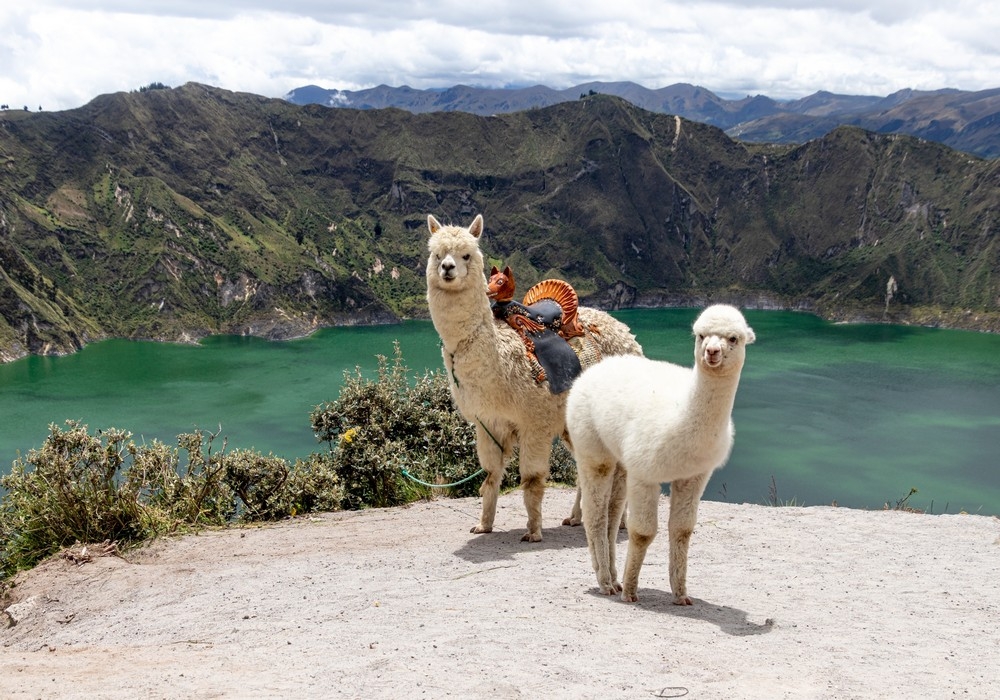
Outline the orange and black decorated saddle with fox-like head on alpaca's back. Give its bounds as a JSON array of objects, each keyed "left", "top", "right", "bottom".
[{"left": 486, "top": 266, "right": 599, "bottom": 394}]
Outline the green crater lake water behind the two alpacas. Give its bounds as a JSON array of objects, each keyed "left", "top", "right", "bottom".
[{"left": 0, "top": 309, "right": 1000, "bottom": 514}]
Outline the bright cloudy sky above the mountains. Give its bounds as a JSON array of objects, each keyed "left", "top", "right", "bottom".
[{"left": 0, "top": 0, "right": 1000, "bottom": 111}]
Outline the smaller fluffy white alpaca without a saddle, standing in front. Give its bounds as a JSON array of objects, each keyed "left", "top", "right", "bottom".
[{"left": 566, "top": 305, "right": 756, "bottom": 605}]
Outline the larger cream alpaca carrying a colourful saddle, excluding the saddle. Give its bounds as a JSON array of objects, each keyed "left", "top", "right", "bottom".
[{"left": 427, "top": 215, "right": 642, "bottom": 542}]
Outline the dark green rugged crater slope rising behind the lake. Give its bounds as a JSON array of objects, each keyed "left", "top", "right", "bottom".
[{"left": 0, "top": 84, "right": 1000, "bottom": 358}]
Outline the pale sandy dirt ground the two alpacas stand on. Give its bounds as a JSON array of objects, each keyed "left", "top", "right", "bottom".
[{"left": 0, "top": 489, "right": 1000, "bottom": 700}]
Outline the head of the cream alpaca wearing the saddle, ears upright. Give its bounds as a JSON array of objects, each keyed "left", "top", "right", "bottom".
[{"left": 427, "top": 214, "right": 486, "bottom": 291}]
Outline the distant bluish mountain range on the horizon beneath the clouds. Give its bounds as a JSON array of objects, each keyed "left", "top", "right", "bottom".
[{"left": 285, "top": 82, "right": 1000, "bottom": 158}]
